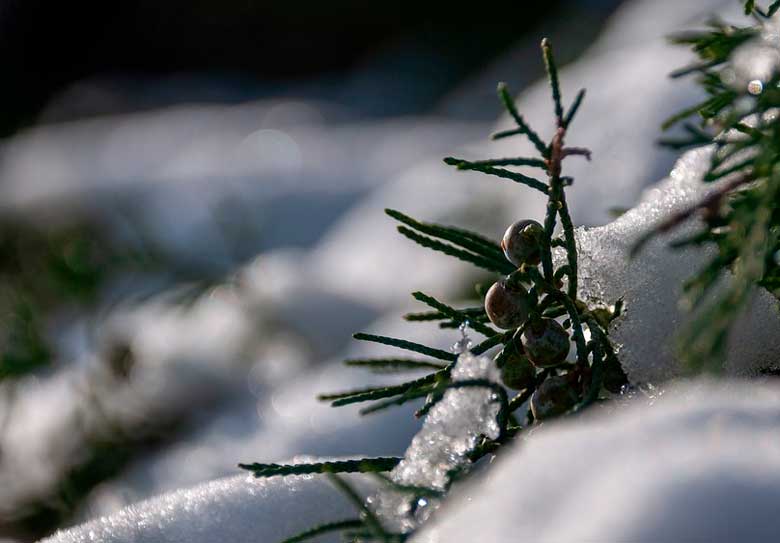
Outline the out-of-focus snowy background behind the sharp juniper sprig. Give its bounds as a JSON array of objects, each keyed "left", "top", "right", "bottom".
[{"left": 0, "top": 0, "right": 723, "bottom": 541}]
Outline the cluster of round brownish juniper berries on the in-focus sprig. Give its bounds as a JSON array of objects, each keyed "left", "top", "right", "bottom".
[{"left": 485, "top": 220, "right": 578, "bottom": 420}]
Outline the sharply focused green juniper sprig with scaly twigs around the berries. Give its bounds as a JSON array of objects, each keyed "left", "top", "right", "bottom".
[{"left": 244, "top": 40, "right": 626, "bottom": 541}]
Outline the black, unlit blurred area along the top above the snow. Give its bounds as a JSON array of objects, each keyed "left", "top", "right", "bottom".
[{"left": 0, "top": 0, "right": 620, "bottom": 135}]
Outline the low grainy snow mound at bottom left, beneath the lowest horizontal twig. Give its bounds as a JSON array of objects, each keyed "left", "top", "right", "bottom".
[{"left": 44, "top": 475, "right": 374, "bottom": 543}]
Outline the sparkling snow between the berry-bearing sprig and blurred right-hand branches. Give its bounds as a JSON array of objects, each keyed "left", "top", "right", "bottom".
[{"left": 558, "top": 148, "right": 780, "bottom": 383}]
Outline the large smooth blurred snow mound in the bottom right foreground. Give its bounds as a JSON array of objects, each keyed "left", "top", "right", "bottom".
[{"left": 412, "top": 380, "right": 780, "bottom": 543}]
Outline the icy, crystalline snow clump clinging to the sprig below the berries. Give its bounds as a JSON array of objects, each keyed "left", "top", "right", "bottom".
[{"left": 369, "top": 351, "right": 501, "bottom": 532}]
